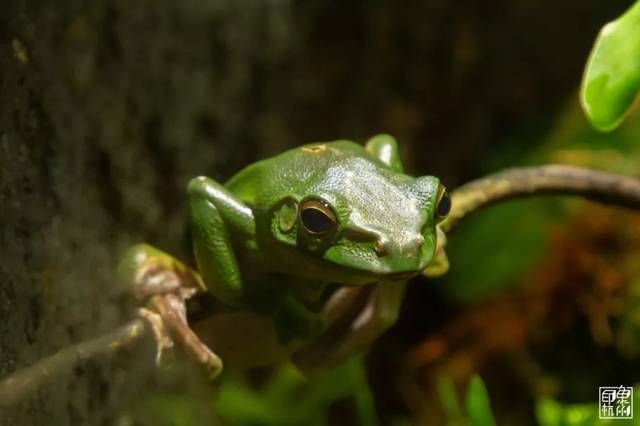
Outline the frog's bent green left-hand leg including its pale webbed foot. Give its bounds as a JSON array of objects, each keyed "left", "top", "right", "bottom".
[{"left": 121, "top": 177, "right": 253, "bottom": 378}]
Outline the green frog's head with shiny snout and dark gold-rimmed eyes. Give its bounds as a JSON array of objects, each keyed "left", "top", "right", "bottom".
[{"left": 272, "top": 158, "right": 451, "bottom": 280}]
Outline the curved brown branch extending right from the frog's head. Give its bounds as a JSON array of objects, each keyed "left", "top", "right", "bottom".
[{"left": 441, "top": 165, "right": 640, "bottom": 232}]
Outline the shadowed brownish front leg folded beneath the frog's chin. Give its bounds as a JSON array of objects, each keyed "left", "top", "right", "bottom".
[{"left": 294, "top": 282, "right": 407, "bottom": 371}]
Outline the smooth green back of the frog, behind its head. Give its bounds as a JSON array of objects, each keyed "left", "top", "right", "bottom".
[{"left": 225, "top": 140, "right": 386, "bottom": 207}]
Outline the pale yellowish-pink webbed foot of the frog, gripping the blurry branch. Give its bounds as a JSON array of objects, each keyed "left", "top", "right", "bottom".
[{"left": 120, "top": 244, "right": 222, "bottom": 379}]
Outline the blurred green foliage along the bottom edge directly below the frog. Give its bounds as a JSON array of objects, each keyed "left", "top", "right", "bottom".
[{"left": 137, "top": 358, "right": 378, "bottom": 426}]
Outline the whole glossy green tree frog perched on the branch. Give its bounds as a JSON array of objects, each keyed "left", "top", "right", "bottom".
[{"left": 121, "top": 135, "right": 451, "bottom": 376}]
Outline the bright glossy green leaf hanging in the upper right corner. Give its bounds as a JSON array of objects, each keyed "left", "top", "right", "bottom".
[{"left": 580, "top": 1, "right": 640, "bottom": 131}]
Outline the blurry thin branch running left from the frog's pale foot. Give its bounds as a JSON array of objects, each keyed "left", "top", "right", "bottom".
[{"left": 0, "top": 318, "right": 147, "bottom": 408}]
